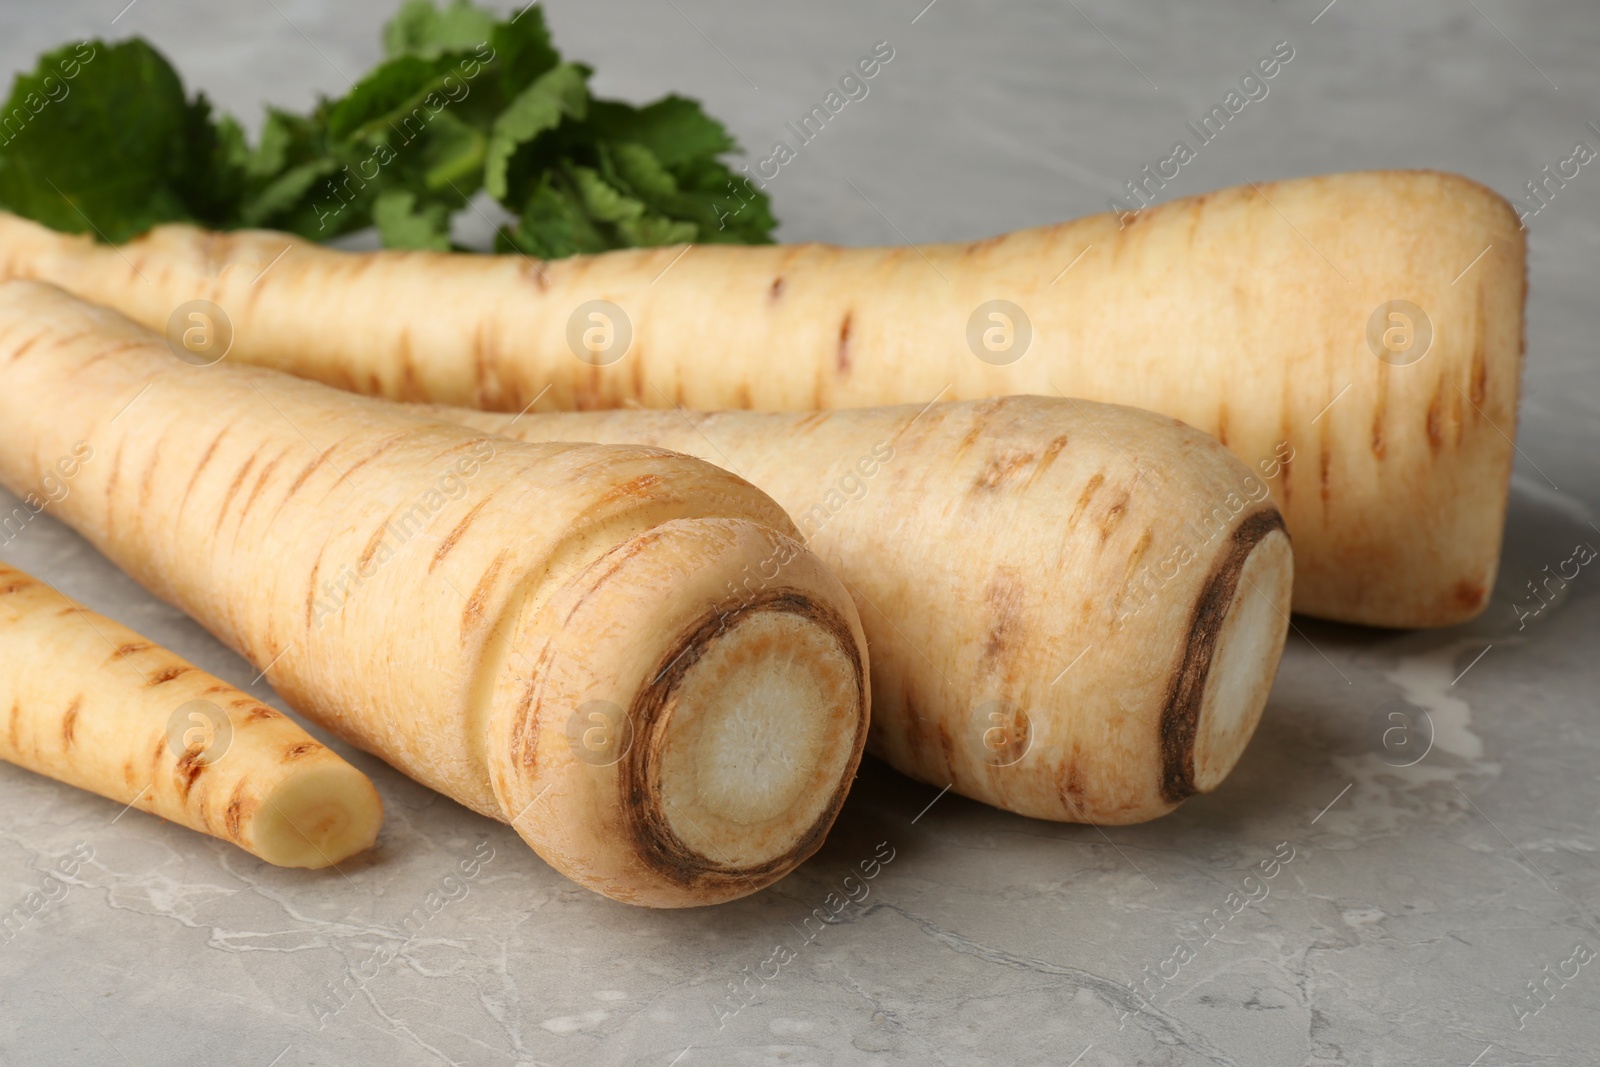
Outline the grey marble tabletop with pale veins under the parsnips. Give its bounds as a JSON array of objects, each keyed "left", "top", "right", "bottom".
[{"left": 0, "top": 0, "right": 1600, "bottom": 1067}]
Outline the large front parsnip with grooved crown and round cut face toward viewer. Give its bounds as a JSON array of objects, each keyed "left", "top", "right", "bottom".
[{"left": 0, "top": 282, "right": 867, "bottom": 907}]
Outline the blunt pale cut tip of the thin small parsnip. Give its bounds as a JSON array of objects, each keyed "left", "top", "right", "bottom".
[{"left": 248, "top": 752, "right": 384, "bottom": 870}]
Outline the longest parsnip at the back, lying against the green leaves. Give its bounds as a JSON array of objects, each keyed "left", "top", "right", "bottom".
[{"left": 0, "top": 171, "right": 1525, "bottom": 627}]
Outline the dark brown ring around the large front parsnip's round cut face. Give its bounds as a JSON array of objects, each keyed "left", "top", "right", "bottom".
[{"left": 618, "top": 589, "right": 869, "bottom": 889}]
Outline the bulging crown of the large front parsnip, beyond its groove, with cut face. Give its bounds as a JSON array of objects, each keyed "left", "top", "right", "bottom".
[{"left": 488, "top": 517, "right": 870, "bottom": 907}]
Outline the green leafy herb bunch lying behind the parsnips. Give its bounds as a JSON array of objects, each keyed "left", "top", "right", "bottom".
[{"left": 0, "top": 0, "right": 776, "bottom": 259}]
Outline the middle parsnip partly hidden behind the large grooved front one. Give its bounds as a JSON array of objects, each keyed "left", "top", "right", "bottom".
[{"left": 427, "top": 397, "right": 1293, "bottom": 822}]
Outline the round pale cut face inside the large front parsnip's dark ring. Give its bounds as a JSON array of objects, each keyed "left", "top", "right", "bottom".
[{"left": 649, "top": 597, "right": 861, "bottom": 872}]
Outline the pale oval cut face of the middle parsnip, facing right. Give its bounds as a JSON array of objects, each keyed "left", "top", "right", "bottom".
[{"left": 1168, "top": 510, "right": 1294, "bottom": 798}]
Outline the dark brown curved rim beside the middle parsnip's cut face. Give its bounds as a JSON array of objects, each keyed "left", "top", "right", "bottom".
[{"left": 1160, "top": 506, "right": 1288, "bottom": 805}]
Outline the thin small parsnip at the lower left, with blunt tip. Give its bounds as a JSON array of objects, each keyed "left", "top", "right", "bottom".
[{"left": 0, "top": 563, "right": 384, "bottom": 867}]
